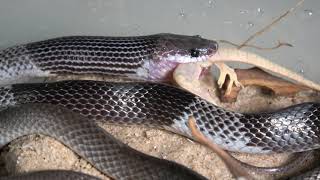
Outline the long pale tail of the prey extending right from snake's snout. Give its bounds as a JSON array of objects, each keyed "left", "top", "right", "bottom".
[{"left": 209, "top": 48, "right": 320, "bottom": 91}]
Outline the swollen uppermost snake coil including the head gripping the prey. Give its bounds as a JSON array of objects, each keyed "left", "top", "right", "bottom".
[{"left": 0, "top": 34, "right": 218, "bottom": 84}]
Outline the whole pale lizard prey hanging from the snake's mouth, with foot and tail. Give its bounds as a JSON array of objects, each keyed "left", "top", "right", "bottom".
[{"left": 173, "top": 48, "right": 320, "bottom": 105}]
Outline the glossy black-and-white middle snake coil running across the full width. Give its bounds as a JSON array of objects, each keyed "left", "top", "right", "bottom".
[{"left": 0, "top": 81, "right": 320, "bottom": 153}]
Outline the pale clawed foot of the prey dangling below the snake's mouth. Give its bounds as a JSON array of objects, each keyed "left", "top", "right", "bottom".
[{"left": 214, "top": 62, "right": 243, "bottom": 94}]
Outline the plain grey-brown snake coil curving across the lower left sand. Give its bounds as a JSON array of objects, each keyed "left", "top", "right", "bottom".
[{"left": 0, "top": 104, "right": 205, "bottom": 180}]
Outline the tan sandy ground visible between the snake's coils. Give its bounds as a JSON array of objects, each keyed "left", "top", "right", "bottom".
[{"left": 0, "top": 83, "right": 320, "bottom": 179}]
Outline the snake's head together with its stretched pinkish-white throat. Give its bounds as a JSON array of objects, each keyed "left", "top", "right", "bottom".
[{"left": 137, "top": 34, "right": 218, "bottom": 82}]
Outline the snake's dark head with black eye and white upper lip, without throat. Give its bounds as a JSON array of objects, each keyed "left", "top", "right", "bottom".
[{"left": 156, "top": 34, "right": 218, "bottom": 63}]
